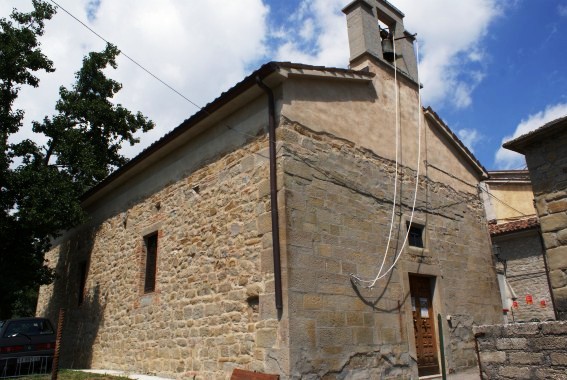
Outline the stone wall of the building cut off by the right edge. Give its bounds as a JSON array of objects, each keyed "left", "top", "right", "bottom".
[{"left": 525, "top": 131, "right": 567, "bottom": 320}]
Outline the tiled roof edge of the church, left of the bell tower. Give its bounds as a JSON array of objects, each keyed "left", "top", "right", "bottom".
[{"left": 81, "top": 62, "right": 375, "bottom": 205}]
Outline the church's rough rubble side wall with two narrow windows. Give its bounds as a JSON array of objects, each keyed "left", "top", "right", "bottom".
[{"left": 38, "top": 135, "right": 287, "bottom": 379}]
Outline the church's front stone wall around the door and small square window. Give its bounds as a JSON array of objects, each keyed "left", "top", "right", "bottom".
[{"left": 279, "top": 120, "right": 501, "bottom": 379}]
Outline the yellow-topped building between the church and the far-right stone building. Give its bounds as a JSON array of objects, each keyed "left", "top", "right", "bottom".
[{"left": 481, "top": 170, "right": 554, "bottom": 323}]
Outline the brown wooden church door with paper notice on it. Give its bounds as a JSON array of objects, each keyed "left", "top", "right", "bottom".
[{"left": 410, "top": 275, "right": 439, "bottom": 376}]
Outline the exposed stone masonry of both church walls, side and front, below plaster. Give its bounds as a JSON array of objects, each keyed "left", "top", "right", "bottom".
[{"left": 38, "top": 112, "right": 501, "bottom": 379}]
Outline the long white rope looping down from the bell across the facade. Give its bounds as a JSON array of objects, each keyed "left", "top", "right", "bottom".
[{"left": 351, "top": 39, "right": 421, "bottom": 289}]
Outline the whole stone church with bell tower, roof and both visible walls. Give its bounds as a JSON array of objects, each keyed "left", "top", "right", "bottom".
[{"left": 37, "top": 0, "right": 502, "bottom": 379}]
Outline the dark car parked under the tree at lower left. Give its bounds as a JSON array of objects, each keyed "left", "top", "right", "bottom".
[{"left": 0, "top": 318, "right": 56, "bottom": 378}]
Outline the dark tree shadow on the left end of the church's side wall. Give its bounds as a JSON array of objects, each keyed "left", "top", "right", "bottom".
[{"left": 45, "top": 228, "right": 105, "bottom": 368}]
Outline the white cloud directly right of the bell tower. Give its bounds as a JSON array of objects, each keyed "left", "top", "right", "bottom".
[{"left": 396, "top": 0, "right": 502, "bottom": 108}]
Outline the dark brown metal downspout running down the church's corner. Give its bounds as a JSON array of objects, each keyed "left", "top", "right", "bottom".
[{"left": 256, "top": 77, "right": 283, "bottom": 313}]
